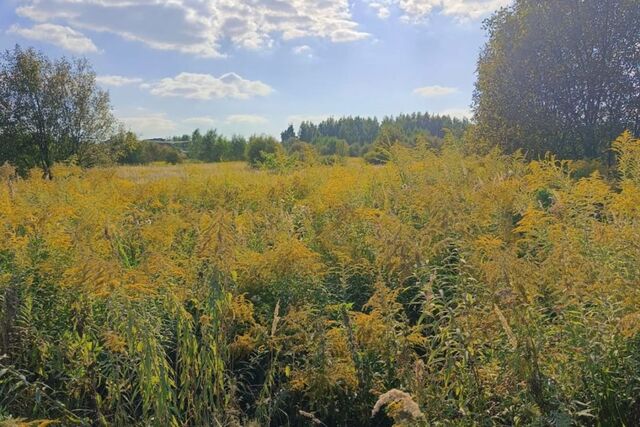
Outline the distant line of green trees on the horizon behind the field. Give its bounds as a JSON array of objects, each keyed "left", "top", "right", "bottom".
[{"left": 152, "top": 113, "right": 471, "bottom": 164}]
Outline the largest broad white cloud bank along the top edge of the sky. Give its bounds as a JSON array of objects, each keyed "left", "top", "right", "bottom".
[{"left": 16, "top": 0, "right": 368, "bottom": 57}]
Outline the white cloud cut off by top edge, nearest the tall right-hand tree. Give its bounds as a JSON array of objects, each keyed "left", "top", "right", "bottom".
[{"left": 366, "top": 0, "right": 512, "bottom": 22}]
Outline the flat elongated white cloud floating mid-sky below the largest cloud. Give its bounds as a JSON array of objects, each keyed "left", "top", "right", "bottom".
[{"left": 147, "top": 73, "right": 273, "bottom": 100}]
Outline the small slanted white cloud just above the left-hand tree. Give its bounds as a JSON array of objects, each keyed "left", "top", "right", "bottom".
[{"left": 9, "top": 24, "right": 98, "bottom": 53}]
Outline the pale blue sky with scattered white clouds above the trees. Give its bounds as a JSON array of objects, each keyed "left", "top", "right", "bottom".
[{"left": 0, "top": 0, "right": 510, "bottom": 138}]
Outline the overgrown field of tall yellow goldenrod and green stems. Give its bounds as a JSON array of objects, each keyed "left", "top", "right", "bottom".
[{"left": 0, "top": 139, "right": 640, "bottom": 426}]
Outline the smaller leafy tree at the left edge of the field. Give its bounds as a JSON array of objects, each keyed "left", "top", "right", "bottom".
[{"left": 0, "top": 46, "right": 115, "bottom": 178}]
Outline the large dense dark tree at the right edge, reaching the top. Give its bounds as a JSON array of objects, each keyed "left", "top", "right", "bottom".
[{"left": 474, "top": 0, "right": 640, "bottom": 159}]
